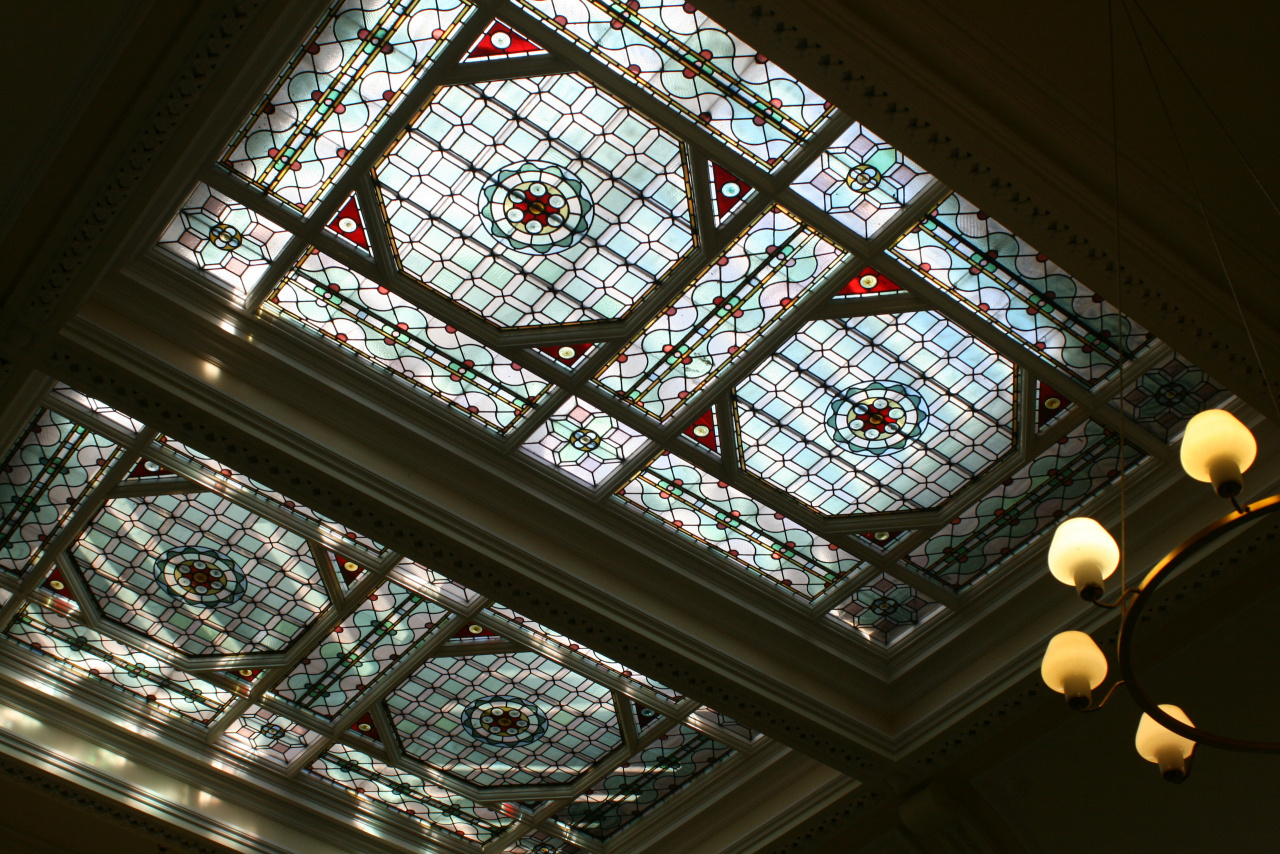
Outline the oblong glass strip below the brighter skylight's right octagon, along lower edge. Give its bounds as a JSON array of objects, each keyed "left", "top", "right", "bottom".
[{"left": 618, "top": 453, "right": 861, "bottom": 598}]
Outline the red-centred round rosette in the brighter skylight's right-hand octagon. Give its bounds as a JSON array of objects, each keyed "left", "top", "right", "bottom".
[{"left": 827, "top": 383, "right": 929, "bottom": 456}]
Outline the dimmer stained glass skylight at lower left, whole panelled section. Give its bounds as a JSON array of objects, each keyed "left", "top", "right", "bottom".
[{"left": 0, "top": 387, "right": 747, "bottom": 851}]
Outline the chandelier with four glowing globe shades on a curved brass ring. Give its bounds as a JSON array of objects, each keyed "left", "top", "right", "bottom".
[{"left": 1041, "top": 410, "right": 1280, "bottom": 782}]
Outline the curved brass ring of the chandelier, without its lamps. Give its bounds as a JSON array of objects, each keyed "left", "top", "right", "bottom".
[{"left": 1116, "top": 494, "right": 1280, "bottom": 754}]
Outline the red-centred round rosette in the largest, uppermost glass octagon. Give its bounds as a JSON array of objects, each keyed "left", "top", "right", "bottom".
[{"left": 480, "top": 160, "right": 593, "bottom": 255}]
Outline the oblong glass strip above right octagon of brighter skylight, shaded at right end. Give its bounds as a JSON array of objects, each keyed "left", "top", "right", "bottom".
[{"left": 893, "top": 195, "right": 1151, "bottom": 385}]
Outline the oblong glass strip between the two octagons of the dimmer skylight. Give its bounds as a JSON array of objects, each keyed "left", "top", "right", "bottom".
[{"left": 276, "top": 581, "right": 448, "bottom": 718}]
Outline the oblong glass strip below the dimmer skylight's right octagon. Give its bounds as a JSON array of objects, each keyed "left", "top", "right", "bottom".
[{"left": 308, "top": 744, "right": 515, "bottom": 842}]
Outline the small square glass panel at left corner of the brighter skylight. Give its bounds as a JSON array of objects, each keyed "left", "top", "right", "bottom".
[{"left": 159, "top": 184, "right": 289, "bottom": 297}]
